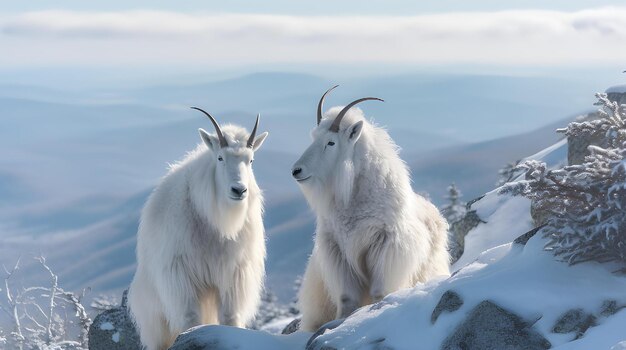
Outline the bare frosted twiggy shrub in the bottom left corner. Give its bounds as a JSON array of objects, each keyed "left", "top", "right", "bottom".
[{"left": 0, "top": 257, "right": 91, "bottom": 350}]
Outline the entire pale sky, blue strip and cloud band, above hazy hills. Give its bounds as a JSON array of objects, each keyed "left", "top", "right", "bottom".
[{"left": 0, "top": 0, "right": 626, "bottom": 69}]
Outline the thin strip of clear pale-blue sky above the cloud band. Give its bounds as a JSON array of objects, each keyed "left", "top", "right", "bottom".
[{"left": 0, "top": 0, "right": 624, "bottom": 15}]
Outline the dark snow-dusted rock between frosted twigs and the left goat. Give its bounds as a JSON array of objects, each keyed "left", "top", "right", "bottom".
[{"left": 89, "top": 291, "right": 141, "bottom": 350}]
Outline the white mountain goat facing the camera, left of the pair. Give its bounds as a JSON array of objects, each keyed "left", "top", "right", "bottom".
[{"left": 129, "top": 107, "right": 268, "bottom": 350}]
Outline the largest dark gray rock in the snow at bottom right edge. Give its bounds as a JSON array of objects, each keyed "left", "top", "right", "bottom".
[{"left": 441, "top": 301, "right": 551, "bottom": 350}]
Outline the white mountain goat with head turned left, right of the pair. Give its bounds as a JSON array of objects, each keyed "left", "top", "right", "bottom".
[{"left": 292, "top": 86, "right": 449, "bottom": 331}]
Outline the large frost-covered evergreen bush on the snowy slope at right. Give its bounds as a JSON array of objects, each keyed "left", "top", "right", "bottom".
[{"left": 500, "top": 94, "right": 626, "bottom": 265}]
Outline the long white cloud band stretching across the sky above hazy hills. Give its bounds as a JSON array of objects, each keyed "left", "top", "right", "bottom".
[{"left": 0, "top": 7, "right": 626, "bottom": 66}]
